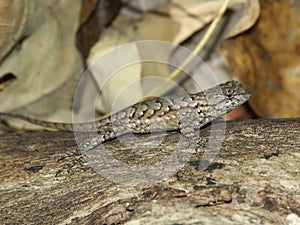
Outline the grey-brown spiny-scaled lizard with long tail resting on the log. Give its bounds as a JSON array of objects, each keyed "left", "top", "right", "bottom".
[{"left": 0, "top": 80, "right": 251, "bottom": 151}]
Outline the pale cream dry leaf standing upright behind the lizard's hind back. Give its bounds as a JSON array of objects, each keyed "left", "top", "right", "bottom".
[{"left": 86, "top": 32, "right": 143, "bottom": 113}]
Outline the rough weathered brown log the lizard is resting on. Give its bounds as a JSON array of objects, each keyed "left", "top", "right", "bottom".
[{"left": 0, "top": 119, "right": 300, "bottom": 224}]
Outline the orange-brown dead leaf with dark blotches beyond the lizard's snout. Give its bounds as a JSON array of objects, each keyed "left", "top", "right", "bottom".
[{"left": 222, "top": 1, "right": 300, "bottom": 117}]
